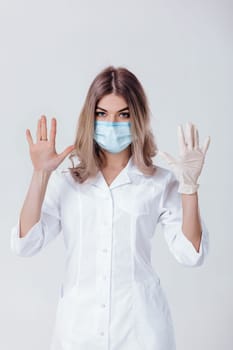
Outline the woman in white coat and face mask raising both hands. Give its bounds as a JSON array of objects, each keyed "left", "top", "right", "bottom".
[{"left": 11, "top": 66, "right": 210, "bottom": 350}]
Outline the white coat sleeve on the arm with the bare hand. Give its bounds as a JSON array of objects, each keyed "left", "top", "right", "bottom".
[{"left": 10, "top": 169, "right": 61, "bottom": 257}]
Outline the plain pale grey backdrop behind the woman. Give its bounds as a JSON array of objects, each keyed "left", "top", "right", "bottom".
[{"left": 0, "top": 0, "right": 233, "bottom": 350}]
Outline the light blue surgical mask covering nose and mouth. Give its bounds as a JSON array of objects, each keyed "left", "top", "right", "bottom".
[{"left": 94, "top": 120, "right": 132, "bottom": 153}]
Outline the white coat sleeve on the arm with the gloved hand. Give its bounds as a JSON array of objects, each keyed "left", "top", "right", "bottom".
[{"left": 158, "top": 171, "right": 209, "bottom": 267}]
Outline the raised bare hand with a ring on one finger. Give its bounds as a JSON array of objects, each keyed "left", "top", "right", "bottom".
[{"left": 26, "top": 115, "right": 74, "bottom": 172}]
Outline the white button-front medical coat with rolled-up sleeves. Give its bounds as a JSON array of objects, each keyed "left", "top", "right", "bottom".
[{"left": 11, "top": 157, "right": 209, "bottom": 350}]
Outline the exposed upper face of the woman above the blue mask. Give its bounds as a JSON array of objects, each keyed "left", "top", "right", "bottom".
[{"left": 95, "top": 93, "right": 131, "bottom": 122}]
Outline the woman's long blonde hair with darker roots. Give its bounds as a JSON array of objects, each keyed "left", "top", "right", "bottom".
[{"left": 69, "top": 66, "right": 158, "bottom": 183}]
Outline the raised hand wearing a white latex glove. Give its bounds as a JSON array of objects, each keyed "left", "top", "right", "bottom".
[{"left": 157, "top": 123, "right": 210, "bottom": 194}]
